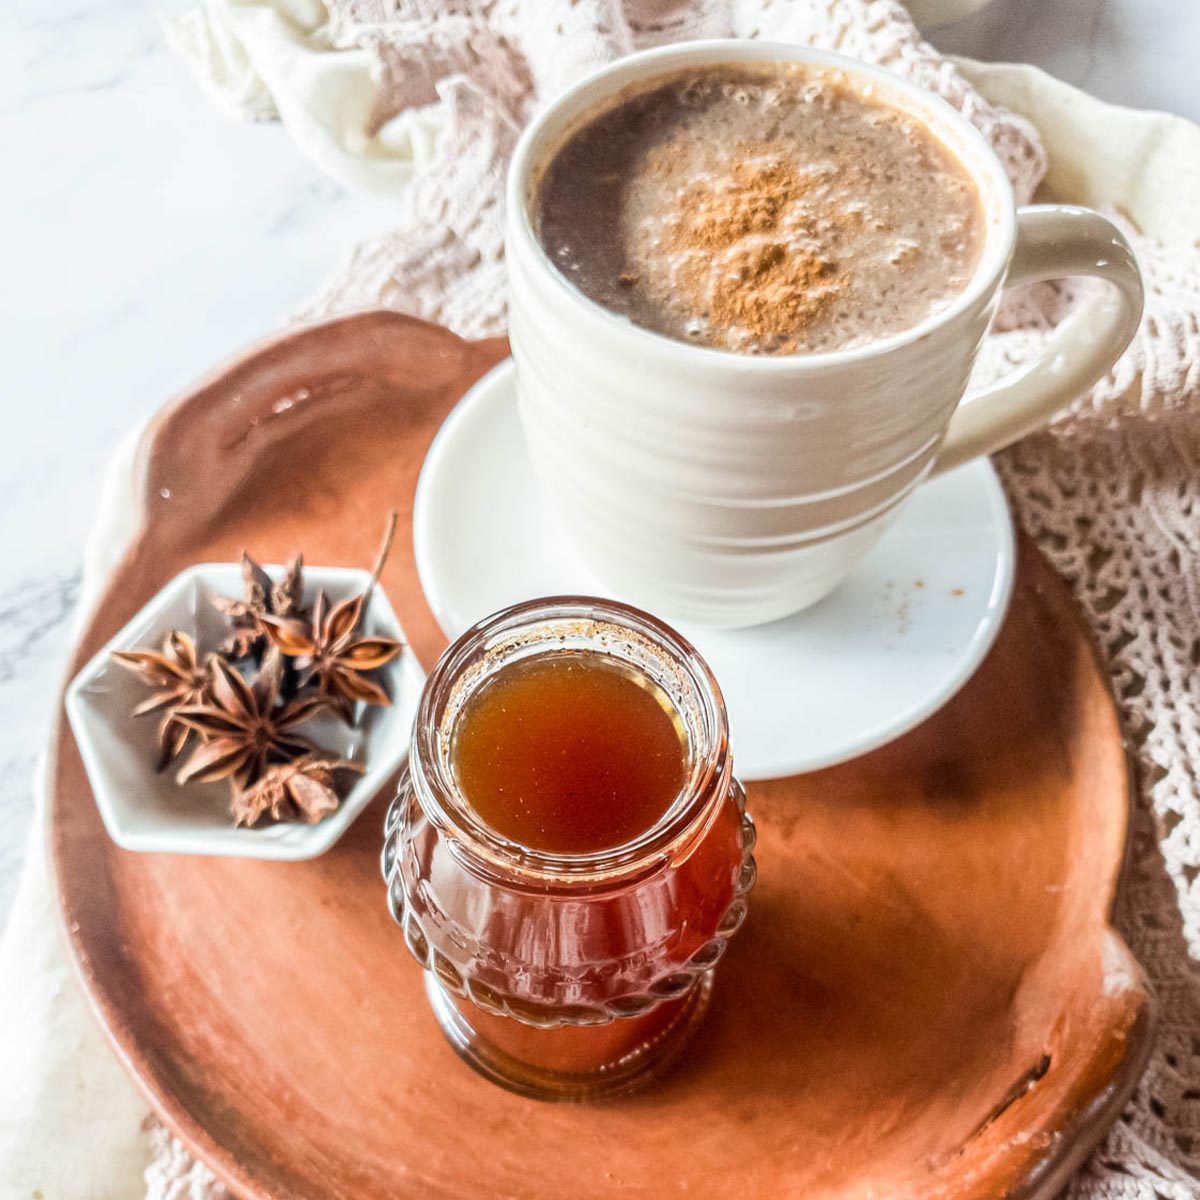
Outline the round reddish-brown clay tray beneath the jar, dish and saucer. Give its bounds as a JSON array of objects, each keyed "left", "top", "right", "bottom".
[{"left": 50, "top": 313, "right": 1151, "bottom": 1200}]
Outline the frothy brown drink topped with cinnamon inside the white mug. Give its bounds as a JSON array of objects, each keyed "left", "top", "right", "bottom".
[{"left": 532, "top": 64, "right": 985, "bottom": 354}]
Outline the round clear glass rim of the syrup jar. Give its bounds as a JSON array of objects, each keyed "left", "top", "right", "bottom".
[{"left": 409, "top": 595, "right": 732, "bottom": 886}]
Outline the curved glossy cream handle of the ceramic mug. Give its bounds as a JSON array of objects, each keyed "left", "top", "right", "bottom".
[{"left": 932, "top": 204, "right": 1144, "bottom": 475}]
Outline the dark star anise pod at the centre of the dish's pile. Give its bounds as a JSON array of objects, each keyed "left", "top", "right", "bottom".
[{"left": 175, "top": 649, "right": 329, "bottom": 786}]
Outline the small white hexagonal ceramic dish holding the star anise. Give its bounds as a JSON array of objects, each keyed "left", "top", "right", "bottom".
[{"left": 66, "top": 563, "right": 424, "bottom": 860}]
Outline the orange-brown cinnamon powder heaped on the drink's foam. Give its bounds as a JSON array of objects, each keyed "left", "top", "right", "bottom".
[{"left": 625, "top": 142, "right": 852, "bottom": 354}]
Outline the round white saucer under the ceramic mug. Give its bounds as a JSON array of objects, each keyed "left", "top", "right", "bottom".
[{"left": 413, "top": 361, "right": 1015, "bottom": 779}]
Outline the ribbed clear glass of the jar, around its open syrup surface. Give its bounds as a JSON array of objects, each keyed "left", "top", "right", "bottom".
[{"left": 383, "top": 596, "right": 755, "bottom": 1099}]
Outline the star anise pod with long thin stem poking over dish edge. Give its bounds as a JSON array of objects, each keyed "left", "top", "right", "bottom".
[{"left": 260, "top": 512, "right": 404, "bottom": 725}]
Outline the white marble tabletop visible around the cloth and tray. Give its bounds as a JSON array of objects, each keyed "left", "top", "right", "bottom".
[{"left": 0, "top": 0, "right": 1200, "bottom": 920}]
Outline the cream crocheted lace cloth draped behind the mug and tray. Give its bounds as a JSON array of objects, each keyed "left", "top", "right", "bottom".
[{"left": 65, "top": 0, "right": 1200, "bottom": 1200}]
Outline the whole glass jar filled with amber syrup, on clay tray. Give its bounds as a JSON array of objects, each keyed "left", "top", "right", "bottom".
[{"left": 383, "top": 598, "right": 754, "bottom": 1099}]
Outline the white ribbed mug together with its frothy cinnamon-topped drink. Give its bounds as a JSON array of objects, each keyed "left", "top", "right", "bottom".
[{"left": 505, "top": 38, "right": 1142, "bottom": 628}]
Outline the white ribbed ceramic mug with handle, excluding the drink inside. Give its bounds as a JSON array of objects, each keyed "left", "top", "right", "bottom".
[{"left": 506, "top": 41, "right": 1142, "bottom": 626}]
